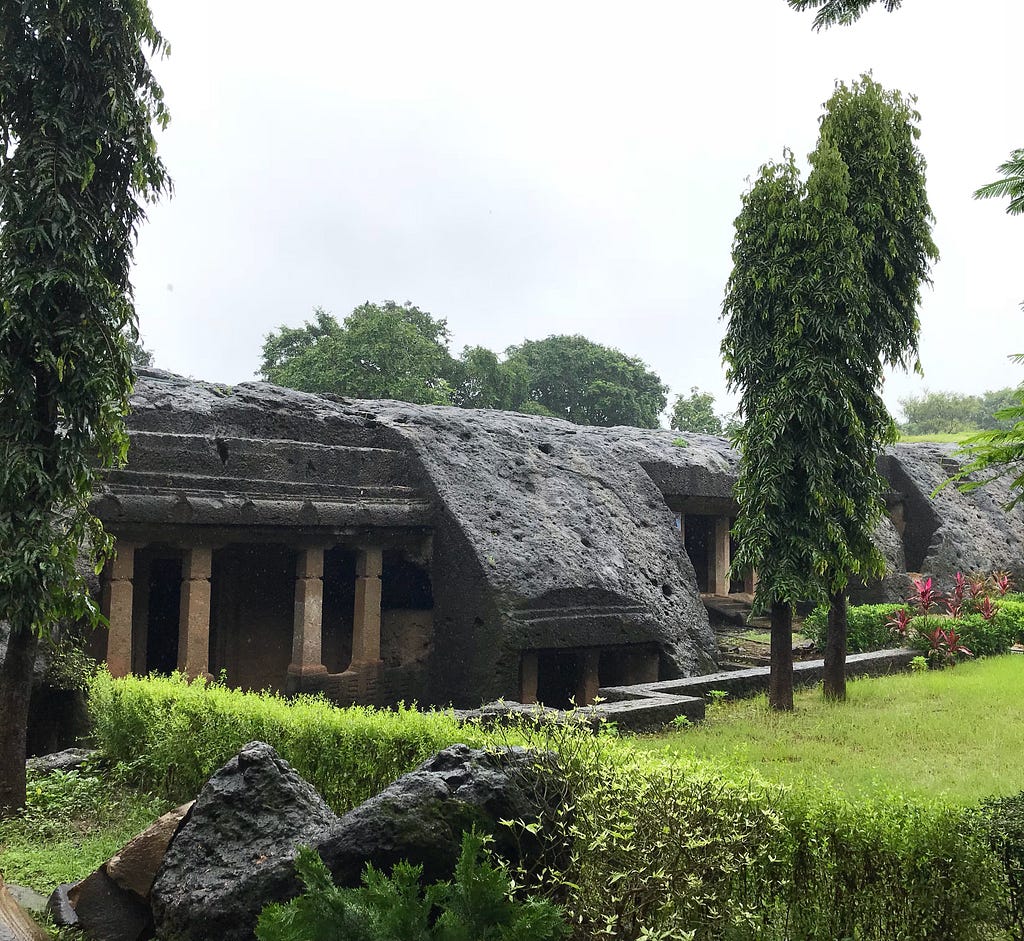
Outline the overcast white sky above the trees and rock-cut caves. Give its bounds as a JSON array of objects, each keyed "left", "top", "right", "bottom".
[{"left": 134, "top": 0, "right": 1024, "bottom": 419}]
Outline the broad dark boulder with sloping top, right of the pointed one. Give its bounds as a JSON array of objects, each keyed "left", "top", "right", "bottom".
[{"left": 316, "top": 745, "right": 564, "bottom": 886}]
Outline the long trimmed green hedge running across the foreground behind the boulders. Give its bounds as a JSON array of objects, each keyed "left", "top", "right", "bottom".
[{"left": 90, "top": 672, "right": 1024, "bottom": 941}]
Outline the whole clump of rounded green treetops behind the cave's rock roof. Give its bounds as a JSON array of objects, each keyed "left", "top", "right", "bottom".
[{"left": 260, "top": 317, "right": 666, "bottom": 428}]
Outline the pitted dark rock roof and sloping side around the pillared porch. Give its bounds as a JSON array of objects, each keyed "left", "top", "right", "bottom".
[{"left": 95, "top": 372, "right": 720, "bottom": 707}]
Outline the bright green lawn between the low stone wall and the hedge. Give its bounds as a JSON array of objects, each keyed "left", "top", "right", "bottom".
[{"left": 636, "top": 655, "right": 1024, "bottom": 805}]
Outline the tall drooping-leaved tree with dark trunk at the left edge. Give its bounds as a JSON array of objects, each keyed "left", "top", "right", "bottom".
[{"left": 0, "top": 0, "right": 169, "bottom": 810}]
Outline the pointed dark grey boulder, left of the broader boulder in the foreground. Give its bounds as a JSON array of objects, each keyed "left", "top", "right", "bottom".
[{"left": 151, "top": 742, "right": 338, "bottom": 941}]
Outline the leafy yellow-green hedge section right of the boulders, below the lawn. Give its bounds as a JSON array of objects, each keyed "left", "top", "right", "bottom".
[{"left": 489, "top": 712, "right": 1000, "bottom": 941}]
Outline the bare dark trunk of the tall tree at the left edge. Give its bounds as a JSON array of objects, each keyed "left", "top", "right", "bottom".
[{"left": 0, "top": 629, "right": 39, "bottom": 817}]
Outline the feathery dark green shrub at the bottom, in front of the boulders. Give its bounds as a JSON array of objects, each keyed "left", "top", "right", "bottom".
[{"left": 256, "top": 832, "right": 567, "bottom": 941}]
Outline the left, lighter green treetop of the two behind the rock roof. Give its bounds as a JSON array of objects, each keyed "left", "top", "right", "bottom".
[{"left": 260, "top": 301, "right": 454, "bottom": 405}]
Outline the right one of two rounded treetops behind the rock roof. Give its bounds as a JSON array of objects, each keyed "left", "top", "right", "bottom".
[{"left": 506, "top": 335, "right": 667, "bottom": 428}]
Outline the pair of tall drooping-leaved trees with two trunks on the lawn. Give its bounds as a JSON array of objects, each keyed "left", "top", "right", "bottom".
[{"left": 722, "top": 77, "right": 935, "bottom": 709}]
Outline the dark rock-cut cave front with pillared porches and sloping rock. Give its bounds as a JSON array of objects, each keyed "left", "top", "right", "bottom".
[{"left": 94, "top": 372, "right": 1024, "bottom": 707}]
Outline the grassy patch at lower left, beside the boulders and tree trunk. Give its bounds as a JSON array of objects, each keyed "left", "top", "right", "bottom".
[{"left": 0, "top": 772, "right": 169, "bottom": 894}]
